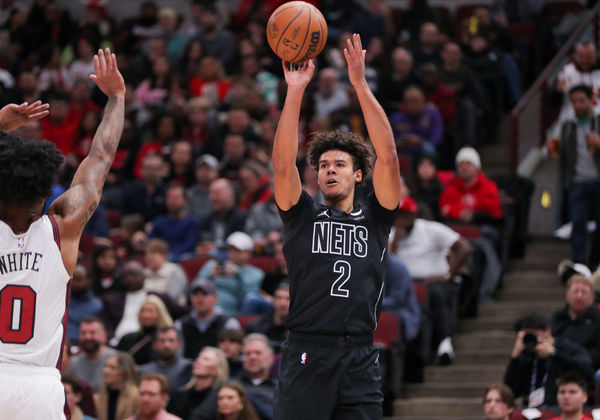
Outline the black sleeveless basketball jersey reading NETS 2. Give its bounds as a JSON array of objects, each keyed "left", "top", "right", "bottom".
[{"left": 279, "top": 191, "right": 395, "bottom": 334}]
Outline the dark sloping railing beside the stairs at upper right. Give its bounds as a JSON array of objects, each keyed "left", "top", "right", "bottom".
[{"left": 509, "top": 3, "right": 600, "bottom": 172}]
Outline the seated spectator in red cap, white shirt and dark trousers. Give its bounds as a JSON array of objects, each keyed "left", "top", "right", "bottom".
[{"left": 390, "top": 197, "right": 471, "bottom": 364}]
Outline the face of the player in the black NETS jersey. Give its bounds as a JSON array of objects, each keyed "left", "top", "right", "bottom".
[{"left": 317, "top": 150, "right": 362, "bottom": 203}]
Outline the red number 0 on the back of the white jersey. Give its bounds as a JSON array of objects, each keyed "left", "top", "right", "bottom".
[{"left": 0, "top": 284, "right": 35, "bottom": 344}]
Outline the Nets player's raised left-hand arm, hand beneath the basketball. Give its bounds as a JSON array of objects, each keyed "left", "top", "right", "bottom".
[{"left": 273, "top": 60, "right": 315, "bottom": 210}]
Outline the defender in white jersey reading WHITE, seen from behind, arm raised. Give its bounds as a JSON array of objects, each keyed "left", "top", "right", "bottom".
[{"left": 0, "top": 49, "right": 125, "bottom": 420}]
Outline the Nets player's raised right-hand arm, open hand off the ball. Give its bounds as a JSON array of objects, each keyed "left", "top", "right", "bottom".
[{"left": 344, "top": 34, "right": 401, "bottom": 210}]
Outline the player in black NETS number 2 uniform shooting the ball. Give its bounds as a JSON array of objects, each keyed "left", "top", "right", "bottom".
[{"left": 273, "top": 34, "right": 401, "bottom": 420}]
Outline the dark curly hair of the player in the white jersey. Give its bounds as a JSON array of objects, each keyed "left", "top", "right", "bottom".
[{"left": 0, "top": 131, "right": 63, "bottom": 208}]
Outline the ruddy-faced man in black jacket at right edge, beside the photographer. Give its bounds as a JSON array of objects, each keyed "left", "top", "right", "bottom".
[{"left": 550, "top": 272, "right": 600, "bottom": 369}]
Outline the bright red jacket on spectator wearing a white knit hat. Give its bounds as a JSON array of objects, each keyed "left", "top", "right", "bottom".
[{"left": 440, "top": 172, "right": 502, "bottom": 219}]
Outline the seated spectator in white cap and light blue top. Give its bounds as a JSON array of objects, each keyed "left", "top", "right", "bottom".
[{"left": 196, "top": 231, "right": 264, "bottom": 316}]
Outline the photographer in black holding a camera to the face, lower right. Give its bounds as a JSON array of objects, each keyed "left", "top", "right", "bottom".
[{"left": 504, "top": 315, "right": 593, "bottom": 407}]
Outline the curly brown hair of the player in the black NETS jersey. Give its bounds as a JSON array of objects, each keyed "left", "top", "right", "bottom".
[{"left": 308, "top": 130, "right": 373, "bottom": 180}]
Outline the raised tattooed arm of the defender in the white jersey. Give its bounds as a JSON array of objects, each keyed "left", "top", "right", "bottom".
[{"left": 48, "top": 48, "right": 125, "bottom": 274}]
